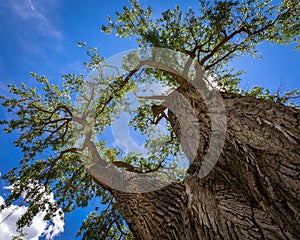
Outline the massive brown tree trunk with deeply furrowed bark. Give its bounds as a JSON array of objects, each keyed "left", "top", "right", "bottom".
[{"left": 113, "top": 92, "right": 300, "bottom": 240}]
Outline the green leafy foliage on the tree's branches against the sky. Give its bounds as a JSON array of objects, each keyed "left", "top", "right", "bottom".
[{"left": 1, "top": 0, "right": 300, "bottom": 239}]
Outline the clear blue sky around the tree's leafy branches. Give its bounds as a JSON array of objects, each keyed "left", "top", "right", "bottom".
[{"left": 0, "top": 0, "right": 300, "bottom": 240}]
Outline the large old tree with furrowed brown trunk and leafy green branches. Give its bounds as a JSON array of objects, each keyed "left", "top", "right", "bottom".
[{"left": 1, "top": 0, "right": 300, "bottom": 239}]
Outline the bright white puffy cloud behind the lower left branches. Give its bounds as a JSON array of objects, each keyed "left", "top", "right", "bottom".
[{"left": 0, "top": 187, "right": 65, "bottom": 240}]
